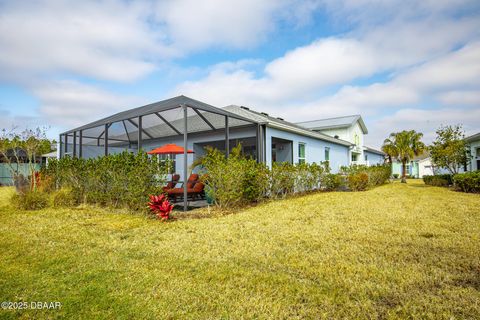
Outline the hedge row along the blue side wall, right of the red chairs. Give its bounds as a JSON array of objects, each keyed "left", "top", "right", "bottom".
[{"left": 200, "top": 147, "right": 391, "bottom": 207}]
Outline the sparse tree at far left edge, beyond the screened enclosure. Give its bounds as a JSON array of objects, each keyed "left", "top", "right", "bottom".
[{"left": 0, "top": 127, "right": 52, "bottom": 191}]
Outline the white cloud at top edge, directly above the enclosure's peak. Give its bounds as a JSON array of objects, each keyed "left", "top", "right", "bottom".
[{"left": 156, "top": 0, "right": 285, "bottom": 50}]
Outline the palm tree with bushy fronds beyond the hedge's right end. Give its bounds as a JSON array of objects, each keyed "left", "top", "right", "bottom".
[{"left": 382, "top": 130, "right": 426, "bottom": 183}]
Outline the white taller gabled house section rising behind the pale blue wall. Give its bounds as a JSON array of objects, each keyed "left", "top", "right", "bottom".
[{"left": 297, "top": 115, "right": 385, "bottom": 165}]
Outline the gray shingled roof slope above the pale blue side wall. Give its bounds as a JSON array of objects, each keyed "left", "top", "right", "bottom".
[{"left": 223, "top": 105, "right": 353, "bottom": 146}]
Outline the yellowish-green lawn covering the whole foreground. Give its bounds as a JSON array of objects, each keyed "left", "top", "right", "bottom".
[{"left": 0, "top": 181, "right": 480, "bottom": 319}]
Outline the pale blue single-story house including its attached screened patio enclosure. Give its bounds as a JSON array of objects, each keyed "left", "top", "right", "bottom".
[{"left": 59, "top": 96, "right": 384, "bottom": 208}]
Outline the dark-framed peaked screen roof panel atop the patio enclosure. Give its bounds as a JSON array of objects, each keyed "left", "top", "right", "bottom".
[{"left": 62, "top": 95, "right": 260, "bottom": 134}]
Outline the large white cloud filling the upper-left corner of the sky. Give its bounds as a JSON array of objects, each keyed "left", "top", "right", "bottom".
[{"left": 0, "top": 1, "right": 168, "bottom": 81}]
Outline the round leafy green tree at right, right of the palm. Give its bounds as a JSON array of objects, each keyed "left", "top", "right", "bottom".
[{"left": 428, "top": 125, "right": 470, "bottom": 174}]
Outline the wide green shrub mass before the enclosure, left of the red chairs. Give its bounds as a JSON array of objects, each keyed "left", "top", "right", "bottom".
[{"left": 42, "top": 151, "right": 168, "bottom": 210}]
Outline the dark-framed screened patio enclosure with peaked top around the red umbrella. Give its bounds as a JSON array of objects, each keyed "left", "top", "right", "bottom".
[{"left": 60, "top": 96, "right": 264, "bottom": 209}]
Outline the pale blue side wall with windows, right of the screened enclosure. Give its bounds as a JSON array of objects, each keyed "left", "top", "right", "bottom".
[{"left": 265, "top": 127, "right": 349, "bottom": 172}]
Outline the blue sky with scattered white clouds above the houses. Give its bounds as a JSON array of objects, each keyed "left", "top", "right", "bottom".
[{"left": 0, "top": 0, "right": 480, "bottom": 147}]
